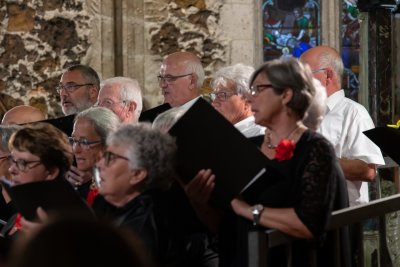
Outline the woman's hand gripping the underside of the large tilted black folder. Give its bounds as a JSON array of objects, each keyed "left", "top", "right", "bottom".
[{"left": 184, "top": 169, "right": 215, "bottom": 205}]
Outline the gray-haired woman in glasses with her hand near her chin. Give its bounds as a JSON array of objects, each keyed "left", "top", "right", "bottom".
[{"left": 66, "top": 107, "right": 120, "bottom": 204}]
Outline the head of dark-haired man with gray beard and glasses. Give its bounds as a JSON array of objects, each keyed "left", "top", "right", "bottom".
[{"left": 57, "top": 65, "right": 100, "bottom": 115}]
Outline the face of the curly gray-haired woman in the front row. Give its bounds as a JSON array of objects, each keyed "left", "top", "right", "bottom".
[{"left": 97, "top": 145, "right": 136, "bottom": 203}]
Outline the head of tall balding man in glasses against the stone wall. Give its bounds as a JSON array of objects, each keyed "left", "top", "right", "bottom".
[{"left": 158, "top": 52, "right": 204, "bottom": 108}]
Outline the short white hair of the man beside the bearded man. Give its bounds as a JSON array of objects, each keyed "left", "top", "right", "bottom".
[{"left": 100, "top": 77, "right": 143, "bottom": 118}]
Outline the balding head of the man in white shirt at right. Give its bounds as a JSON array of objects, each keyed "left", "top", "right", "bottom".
[{"left": 300, "top": 46, "right": 344, "bottom": 96}]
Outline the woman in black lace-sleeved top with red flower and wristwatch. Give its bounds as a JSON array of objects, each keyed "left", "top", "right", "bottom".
[{"left": 186, "top": 59, "right": 343, "bottom": 266}]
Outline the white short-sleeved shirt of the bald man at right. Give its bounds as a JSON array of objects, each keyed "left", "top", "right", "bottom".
[{"left": 318, "top": 90, "right": 385, "bottom": 206}]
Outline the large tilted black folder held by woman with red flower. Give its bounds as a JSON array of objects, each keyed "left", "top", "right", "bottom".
[{"left": 169, "top": 98, "right": 266, "bottom": 206}]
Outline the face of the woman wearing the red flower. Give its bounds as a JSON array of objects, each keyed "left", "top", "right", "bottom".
[{"left": 249, "top": 73, "right": 284, "bottom": 127}]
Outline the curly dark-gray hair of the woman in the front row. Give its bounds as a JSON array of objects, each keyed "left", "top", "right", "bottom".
[{"left": 107, "top": 123, "right": 176, "bottom": 190}]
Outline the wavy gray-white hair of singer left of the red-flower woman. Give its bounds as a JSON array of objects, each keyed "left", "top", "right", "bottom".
[{"left": 211, "top": 63, "right": 254, "bottom": 95}]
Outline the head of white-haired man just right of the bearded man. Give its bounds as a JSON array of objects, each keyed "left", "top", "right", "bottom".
[{"left": 97, "top": 77, "right": 142, "bottom": 123}]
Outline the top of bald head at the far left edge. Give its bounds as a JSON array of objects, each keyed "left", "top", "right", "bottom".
[{"left": 1, "top": 106, "right": 46, "bottom": 125}]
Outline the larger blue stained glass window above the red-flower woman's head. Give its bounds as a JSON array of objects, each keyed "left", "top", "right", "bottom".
[{"left": 262, "top": 0, "right": 321, "bottom": 61}]
